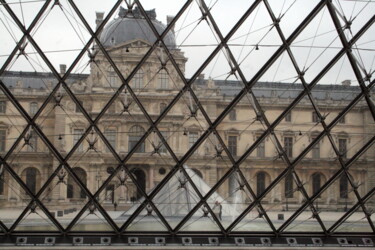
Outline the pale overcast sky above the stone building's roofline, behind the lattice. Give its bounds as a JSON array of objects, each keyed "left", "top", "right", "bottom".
[{"left": 0, "top": 0, "right": 375, "bottom": 84}]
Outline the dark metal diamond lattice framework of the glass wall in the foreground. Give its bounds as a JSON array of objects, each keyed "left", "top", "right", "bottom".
[{"left": 0, "top": 0, "right": 375, "bottom": 247}]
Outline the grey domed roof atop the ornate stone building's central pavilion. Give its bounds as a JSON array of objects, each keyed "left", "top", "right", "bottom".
[{"left": 100, "top": 8, "right": 176, "bottom": 48}]
